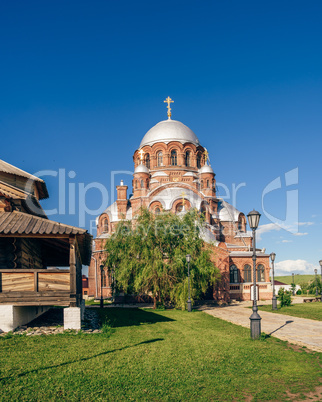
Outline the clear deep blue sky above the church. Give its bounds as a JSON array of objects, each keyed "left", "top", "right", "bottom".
[{"left": 0, "top": 0, "right": 322, "bottom": 273}]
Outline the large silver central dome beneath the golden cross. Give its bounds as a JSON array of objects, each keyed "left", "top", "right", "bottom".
[{"left": 140, "top": 119, "right": 200, "bottom": 148}]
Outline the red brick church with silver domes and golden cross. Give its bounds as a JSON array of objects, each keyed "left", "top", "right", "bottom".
[{"left": 88, "top": 97, "right": 272, "bottom": 301}]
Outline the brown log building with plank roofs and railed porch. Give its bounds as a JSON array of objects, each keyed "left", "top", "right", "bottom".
[{"left": 0, "top": 160, "right": 91, "bottom": 331}]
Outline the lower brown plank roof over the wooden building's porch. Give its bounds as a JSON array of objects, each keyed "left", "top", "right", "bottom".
[{"left": 0, "top": 211, "right": 92, "bottom": 265}]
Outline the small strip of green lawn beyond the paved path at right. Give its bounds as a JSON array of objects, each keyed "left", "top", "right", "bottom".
[{"left": 258, "top": 302, "right": 322, "bottom": 321}]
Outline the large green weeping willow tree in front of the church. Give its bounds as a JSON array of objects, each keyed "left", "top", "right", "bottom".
[{"left": 105, "top": 208, "right": 220, "bottom": 309}]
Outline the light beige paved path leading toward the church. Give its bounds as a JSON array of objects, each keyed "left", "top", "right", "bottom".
[{"left": 203, "top": 305, "right": 322, "bottom": 352}]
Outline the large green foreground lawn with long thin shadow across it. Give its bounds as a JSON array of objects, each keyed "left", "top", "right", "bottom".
[{"left": 0, "top": 308, "right": 322, "bottom": 401}]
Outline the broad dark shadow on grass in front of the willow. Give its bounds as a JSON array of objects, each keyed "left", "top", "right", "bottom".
[{"left": 99, "top": 308, "right": 175, "bottom": 328}]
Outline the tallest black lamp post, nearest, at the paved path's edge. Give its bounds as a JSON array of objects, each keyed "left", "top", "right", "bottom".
[{"left": 247, "top": 209, "right": 261, "bottom": 339}]
